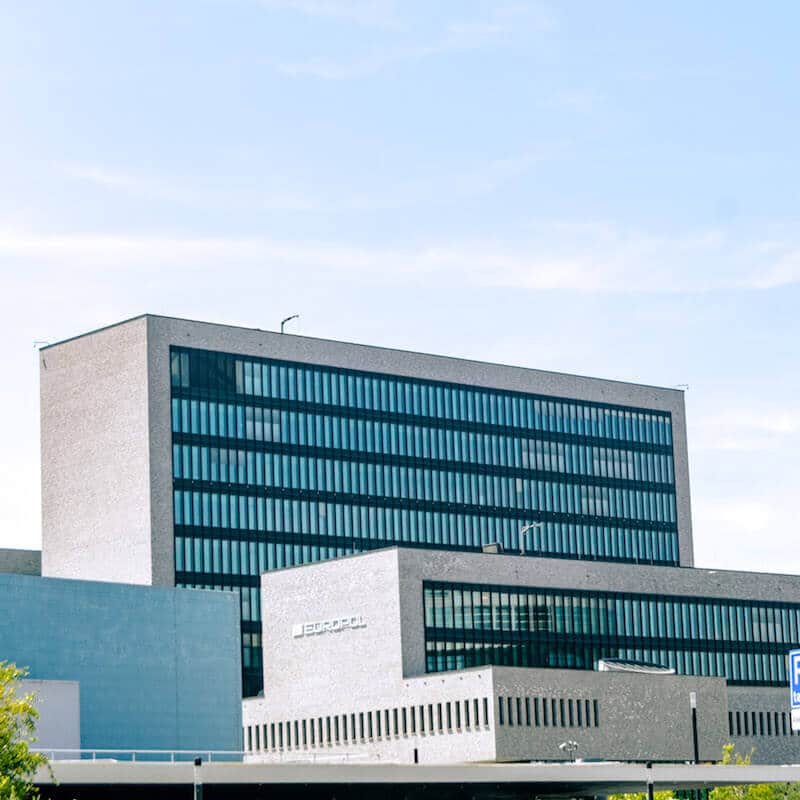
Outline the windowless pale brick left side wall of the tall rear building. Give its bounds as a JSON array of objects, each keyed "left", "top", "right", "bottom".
[{"left": 39, "top": 318, "right": 158, "bottom": 584}]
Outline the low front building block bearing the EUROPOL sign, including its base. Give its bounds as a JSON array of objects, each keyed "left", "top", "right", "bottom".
[{"left": 243, "top": 548, "right": 800, "bottom": 763}]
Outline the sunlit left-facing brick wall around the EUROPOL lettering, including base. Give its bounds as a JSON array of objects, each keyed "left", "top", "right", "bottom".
[{"left": 248, "top": 550, "right": 495, "bottom": 763}]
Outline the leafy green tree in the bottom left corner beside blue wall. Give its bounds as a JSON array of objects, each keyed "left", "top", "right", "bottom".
[{"left": 0, "top": 661, "right": 47, "bottom": 800}]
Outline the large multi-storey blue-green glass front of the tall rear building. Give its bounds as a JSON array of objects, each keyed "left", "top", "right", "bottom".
[{"left": 171, "top": 348, "right": 678, "bottom": 694}]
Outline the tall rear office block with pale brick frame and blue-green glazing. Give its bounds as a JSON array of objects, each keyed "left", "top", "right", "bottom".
[{"left": 40, "top": 315, "right": 693, "bottom": 695}]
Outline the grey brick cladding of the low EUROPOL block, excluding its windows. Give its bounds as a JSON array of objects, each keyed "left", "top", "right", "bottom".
[{"left": 243, "top": 548, "right": 800, "bottom": 763}]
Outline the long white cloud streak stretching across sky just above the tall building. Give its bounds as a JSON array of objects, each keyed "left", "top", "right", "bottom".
[{"left": 0, "top": 223, "right": 800, "bottom": 296}]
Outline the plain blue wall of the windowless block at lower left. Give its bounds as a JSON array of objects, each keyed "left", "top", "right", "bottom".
[{"left": 0, "top": 575, "right": 242, "bottom": 750}]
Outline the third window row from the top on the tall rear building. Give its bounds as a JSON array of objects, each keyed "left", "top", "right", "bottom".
[{"left": 172, "top": 444, "right": 676, "bottom": 523}]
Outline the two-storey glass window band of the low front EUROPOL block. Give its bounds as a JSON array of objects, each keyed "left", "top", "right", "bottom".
[{"left": 423, "top": 582, "right": 800, "bottom": 686}]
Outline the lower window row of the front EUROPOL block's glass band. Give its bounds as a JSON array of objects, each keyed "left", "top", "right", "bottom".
[{"left": 426, "top": 631, "right": 787, "bottom": 686}]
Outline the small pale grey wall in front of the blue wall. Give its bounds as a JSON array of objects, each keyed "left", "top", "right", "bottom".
[{"left": 21, "top": 680, "right": 81, "bottom": 758}]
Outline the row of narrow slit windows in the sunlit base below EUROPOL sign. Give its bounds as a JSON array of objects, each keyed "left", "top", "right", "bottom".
[{"left": 244, "top": 697, "right": 489, "bottom": 753}]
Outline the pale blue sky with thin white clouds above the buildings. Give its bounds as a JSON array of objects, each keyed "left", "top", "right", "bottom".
[{"left": 0, "top": 0, "right": 800, "bottom": 573}]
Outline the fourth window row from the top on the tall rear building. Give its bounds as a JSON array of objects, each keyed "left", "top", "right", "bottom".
[{"left": 173, "top": 489, "right": 678, "bottom": 574}]
